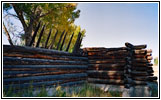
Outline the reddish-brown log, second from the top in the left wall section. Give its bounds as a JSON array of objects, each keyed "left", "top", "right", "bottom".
[{"left": 3, "top": 52, "right": 88, "bottom": 61}]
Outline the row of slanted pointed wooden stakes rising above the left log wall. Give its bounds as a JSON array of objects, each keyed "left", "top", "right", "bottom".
[{"left": 27, "top": 22, "right": 83, "bottom": 53}]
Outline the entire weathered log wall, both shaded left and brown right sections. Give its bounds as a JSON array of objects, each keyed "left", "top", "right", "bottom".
[{"left": 3, "top": 43, "right": 157, "bottom": 89}]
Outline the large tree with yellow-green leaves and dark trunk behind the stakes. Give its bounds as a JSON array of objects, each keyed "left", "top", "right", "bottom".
[{"left": 3, "top": 3, "right": 85, "bottom": 49}]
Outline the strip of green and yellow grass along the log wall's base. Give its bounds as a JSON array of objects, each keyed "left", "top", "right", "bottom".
[{"left": 3, "top": 84, "right": 122, "bottom": 97}]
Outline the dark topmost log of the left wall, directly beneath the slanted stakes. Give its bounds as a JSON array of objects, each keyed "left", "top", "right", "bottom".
[{"left": 3, "top": 45, "right": 80, "bottom": 56}]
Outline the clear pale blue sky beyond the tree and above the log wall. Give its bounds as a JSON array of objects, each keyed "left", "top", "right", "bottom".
[{"left": 3, "top": 3, "right": 159, "bottom": 57}]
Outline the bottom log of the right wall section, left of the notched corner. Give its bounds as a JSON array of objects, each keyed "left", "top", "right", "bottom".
[{"left": 87, "top": 78, "right": 124, "bottom": 84}]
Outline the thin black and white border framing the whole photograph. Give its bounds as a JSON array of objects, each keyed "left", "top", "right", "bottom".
[{"left": 1, "top": 1, "right": 160, "bottom": 99}]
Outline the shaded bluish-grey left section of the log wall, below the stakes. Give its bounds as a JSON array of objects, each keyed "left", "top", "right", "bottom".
[{"left": 3, "top": 45, "right": 88, "bottom": 89}]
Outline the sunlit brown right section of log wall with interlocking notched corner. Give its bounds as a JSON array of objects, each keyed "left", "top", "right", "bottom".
[{"left": 83, "top": 43, "right": 157, "bottom": 88}]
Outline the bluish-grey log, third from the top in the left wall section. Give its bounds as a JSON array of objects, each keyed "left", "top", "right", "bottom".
[{"left": 3, "top": 57, "right": 87, "bottom": 65}]
